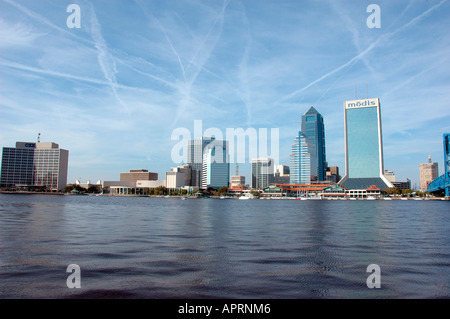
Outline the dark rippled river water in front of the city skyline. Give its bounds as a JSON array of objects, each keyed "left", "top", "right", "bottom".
[{"left": 0, "top": 194, "right": 450, "bottom": 299}]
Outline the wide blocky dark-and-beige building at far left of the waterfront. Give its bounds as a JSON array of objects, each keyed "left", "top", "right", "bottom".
[{"left": 0, "top": 142, "right": 69, "bottom": 190}]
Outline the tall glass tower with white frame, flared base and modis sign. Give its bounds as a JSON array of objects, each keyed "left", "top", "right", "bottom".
[{"left": 339, "top": 98, "right": 393, "bottom": 190}]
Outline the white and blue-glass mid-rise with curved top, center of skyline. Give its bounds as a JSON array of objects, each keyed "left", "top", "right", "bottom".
[{"left": 201, "top": 138, "right": 230, "bottom": 189}]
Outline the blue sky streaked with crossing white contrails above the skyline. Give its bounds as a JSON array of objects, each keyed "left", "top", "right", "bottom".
[{"left": 0, "top": 0, "right": 450, "bottom": 189}]
